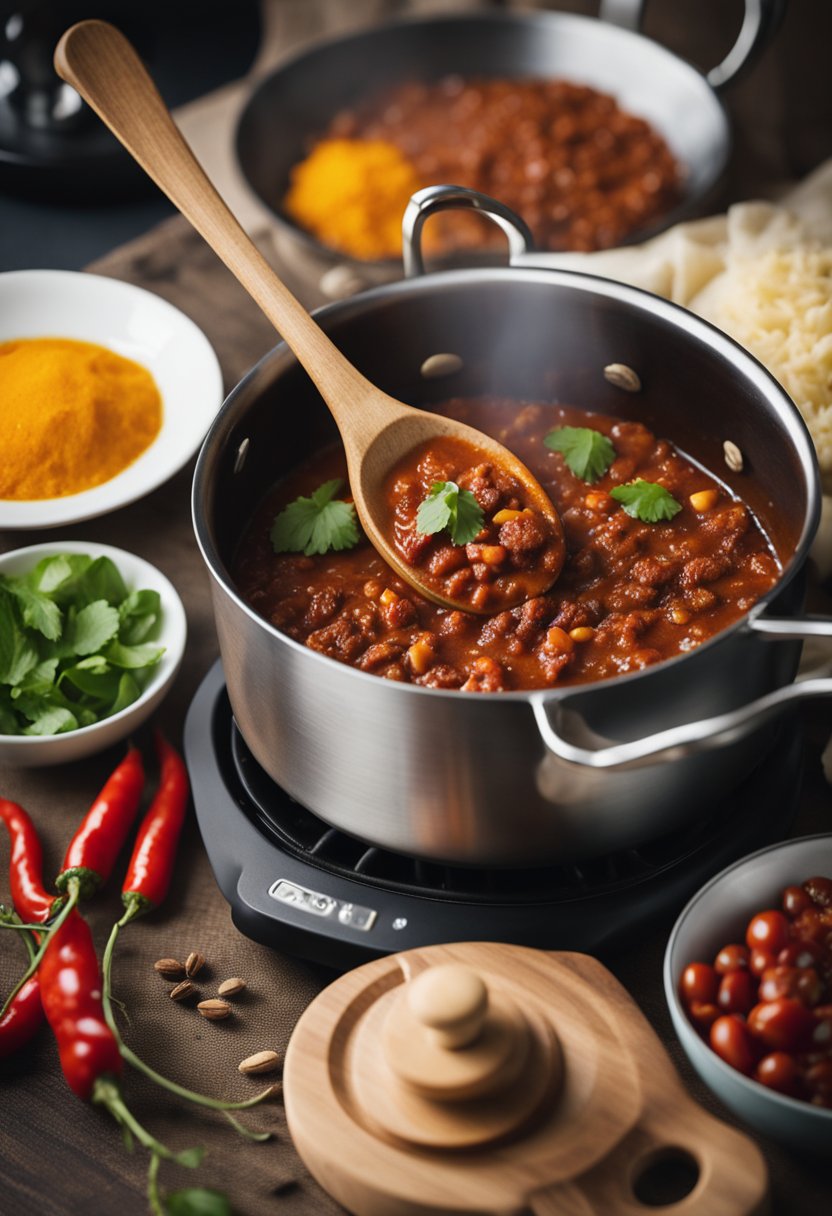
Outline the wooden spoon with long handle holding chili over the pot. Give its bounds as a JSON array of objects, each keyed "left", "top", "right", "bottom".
[{"left": 55, "top": 21, "right": 566, "bottom": 612}]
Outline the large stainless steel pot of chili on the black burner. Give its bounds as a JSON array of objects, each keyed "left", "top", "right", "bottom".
[{"left": 193, "top": 259, "right": 832, "bottom": 865}]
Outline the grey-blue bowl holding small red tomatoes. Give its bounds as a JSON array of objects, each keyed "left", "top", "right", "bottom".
[{"left": 664, "top": 834, "right": 832, "bottom": 1155}]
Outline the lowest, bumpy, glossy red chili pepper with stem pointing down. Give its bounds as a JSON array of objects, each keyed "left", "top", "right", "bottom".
[{"left": 38, "top": 908, "right": 122, "bottom": 1102}]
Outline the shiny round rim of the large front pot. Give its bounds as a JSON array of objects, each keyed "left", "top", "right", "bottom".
[{"left": 191, "top": 266, "right": 821, "bottom": 704}]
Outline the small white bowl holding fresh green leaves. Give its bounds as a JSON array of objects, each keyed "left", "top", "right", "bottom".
[{"left": 0, "top": 541, "right": 187, "bottom": 767}]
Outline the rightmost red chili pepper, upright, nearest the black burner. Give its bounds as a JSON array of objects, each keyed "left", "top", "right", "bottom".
[{"left": 122, "top": 731, "right": 190, "bottom": 916}]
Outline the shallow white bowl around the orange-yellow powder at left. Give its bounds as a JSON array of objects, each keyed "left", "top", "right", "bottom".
[{"left": 0, "top": 270, "right": 223, "bottom": 529}]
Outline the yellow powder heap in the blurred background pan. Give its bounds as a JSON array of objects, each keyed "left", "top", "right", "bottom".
[{"left": 283, "top": 140, "right": 425, "bottom": 259}]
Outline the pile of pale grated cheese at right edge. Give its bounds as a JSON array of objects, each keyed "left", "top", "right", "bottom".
[{"left": 707, "top": 244, "right": 832, "bottom": 491}]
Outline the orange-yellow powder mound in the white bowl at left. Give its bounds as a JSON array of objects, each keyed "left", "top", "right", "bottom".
[{"left": 0, "top": 338, "right": 162, "bottom": 500}]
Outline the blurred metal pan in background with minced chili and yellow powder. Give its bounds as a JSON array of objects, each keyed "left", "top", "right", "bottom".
[{"left": 236, "top": 0, "right": 786, "bottom": 299}]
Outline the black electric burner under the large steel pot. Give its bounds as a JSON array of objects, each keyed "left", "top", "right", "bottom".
[{"left": 185, "top": 662, "right": 803, "bottom": 968}]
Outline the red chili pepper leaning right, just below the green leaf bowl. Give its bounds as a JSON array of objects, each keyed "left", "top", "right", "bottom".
[{"left": 55, "top": 748, "right": 145, "bottom": 899}]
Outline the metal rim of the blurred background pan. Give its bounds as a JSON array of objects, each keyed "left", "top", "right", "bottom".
[{"left": 234, "top": 9, "right": 733, "bottom": 274}]
